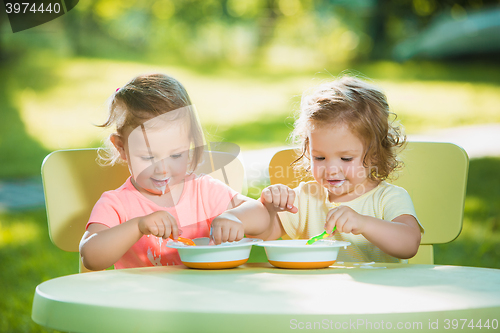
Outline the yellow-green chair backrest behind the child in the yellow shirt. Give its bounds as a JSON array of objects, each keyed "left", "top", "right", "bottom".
[{"left": 269, "top": 142, "right": 469, "bottom": 264}]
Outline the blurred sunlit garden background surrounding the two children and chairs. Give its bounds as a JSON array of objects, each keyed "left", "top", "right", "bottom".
[{"left": 0, "top": 0, "right": 500, "bottom": 332}]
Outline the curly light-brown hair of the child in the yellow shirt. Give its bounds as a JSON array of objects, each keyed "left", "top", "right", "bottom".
[{"left": 291, "top": 76, "right": 406, "bottom": 180}]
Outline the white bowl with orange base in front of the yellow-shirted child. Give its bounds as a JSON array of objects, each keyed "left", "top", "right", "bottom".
[{"left": 256, "top": 239, "right": 351, "bottom": 268}]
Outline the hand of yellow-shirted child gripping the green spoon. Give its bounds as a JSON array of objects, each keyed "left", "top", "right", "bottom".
[{"left": 325, "top": 206, "right": 366, "bottom": 235}]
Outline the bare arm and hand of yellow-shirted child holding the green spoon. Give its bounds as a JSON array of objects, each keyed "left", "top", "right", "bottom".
[{"left": 325, "top": 206, "right": 421, "bottom": 259}]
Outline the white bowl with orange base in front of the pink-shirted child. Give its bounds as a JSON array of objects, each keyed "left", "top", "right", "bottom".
[{"left": 167, "top": 237, "right": 262, "bottom": 269}]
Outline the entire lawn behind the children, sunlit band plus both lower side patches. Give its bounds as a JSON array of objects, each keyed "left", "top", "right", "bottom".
[{"left": 0, "top": 53, "right": 500, "bottom": 332}]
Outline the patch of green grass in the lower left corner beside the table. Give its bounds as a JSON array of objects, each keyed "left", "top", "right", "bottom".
[{"left": 0, "top": 209, "right": 78, "bottom": 332}]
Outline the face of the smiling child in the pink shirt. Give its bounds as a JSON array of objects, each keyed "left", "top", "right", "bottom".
[{"left": 115, "top": 117, "right": 191, "bottom": 195}]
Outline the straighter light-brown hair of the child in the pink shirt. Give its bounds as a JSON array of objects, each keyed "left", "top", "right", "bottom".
[{"left": 97, "top": 73, "right": 204, "bottom": 170}]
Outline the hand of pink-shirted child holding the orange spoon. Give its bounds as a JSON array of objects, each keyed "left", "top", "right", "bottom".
[{"left": 139, "top": 210, "right": 179, "bottom": 239}]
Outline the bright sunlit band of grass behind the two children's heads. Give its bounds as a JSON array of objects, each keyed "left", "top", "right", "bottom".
[{"left": 0, "top": 51, "right": 500, "bottom": 178}]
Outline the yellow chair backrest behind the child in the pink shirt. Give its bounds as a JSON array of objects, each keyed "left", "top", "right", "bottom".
[{"left": 42, "top": 149, "right": 246, "bottom": 271}]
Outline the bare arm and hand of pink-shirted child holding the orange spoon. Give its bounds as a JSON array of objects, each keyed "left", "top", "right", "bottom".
[{"left": 80, "top": 211, "right": 179, "bottom": 271}]
